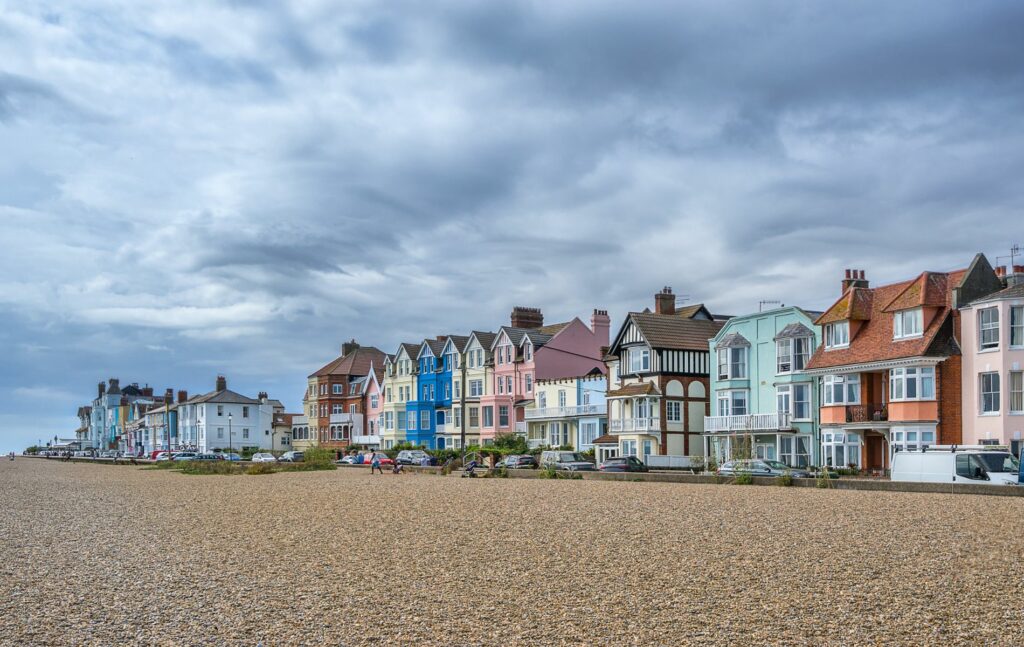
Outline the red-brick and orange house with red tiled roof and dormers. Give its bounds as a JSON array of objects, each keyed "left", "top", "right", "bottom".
[{"left": 806, "top": 254, "right": 998, "bottom": 471}]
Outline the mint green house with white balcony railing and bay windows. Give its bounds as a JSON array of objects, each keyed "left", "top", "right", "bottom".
[{"left": 703, "top": 307, "right": 821, "bottom": 467}]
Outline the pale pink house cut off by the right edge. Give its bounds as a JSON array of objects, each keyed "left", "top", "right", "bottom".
[{"left": 961, "top": 265, "right": 1024, "bottom": 456}]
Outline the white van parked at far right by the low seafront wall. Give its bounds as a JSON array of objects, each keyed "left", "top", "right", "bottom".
[{"left": 891, "top": 445, "right": 1020, "bottom": 485}]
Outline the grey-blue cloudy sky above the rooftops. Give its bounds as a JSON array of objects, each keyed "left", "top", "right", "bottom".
[{"left": 0, "top": 0, "right": 1024, "bottom": 450}]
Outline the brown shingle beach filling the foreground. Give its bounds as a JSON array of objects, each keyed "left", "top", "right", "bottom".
[{"left": 0, "top": 459, "right": 1024, "bottom": 647}]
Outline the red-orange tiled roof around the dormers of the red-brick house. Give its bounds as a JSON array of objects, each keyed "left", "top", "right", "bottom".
[{"left": 807, "top": 268, "right": 970, "bottom": 371}]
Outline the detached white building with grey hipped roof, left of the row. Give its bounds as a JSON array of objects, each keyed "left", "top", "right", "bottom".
[{"left": 178, "top": 376, "right": 284, "bottom": 451}]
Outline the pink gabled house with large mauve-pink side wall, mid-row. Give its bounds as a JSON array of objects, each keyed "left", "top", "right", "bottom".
[{"left": 480, "top": 306, "right": 611, "bottom": 444}]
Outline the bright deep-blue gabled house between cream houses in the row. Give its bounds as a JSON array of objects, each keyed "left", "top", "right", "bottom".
[{"left": 406, "top": 337, "right": 452, "bottom": 449}]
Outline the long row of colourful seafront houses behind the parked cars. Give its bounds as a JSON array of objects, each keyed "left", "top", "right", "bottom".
[{"left": 75, "top": 254, "right": 1024, "bottom": 472}]
